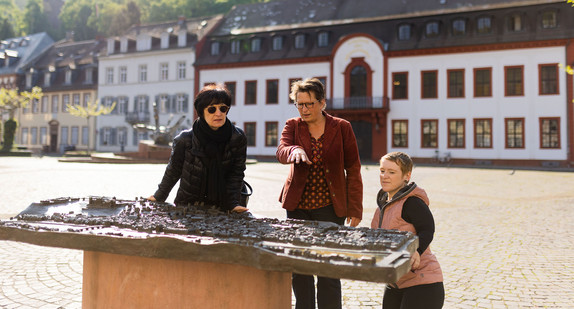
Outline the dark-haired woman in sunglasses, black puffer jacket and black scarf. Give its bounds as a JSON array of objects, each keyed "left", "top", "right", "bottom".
[{"left": 148, "top": 85, "right": 248, "bottom": 212}]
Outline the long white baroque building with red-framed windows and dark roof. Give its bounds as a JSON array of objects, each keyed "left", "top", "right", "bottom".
[{"left": 195, "top": 0, "right": 574, "bottom": 166}]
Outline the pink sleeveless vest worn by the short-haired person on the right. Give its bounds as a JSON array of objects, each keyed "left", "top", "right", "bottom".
[{"left": 371, "top": 187, "right": 443, "bottom": 289}]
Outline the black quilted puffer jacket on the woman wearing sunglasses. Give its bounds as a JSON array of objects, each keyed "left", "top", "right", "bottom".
[{"left": 154, "top": 126, "right": 247, "bottom": 210}]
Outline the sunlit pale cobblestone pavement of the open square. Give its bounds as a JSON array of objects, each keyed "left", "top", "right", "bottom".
[{"left": 0, "top": 157, "right": 574, "bottom": 309}]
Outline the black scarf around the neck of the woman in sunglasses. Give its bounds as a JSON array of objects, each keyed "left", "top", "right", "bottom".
[{"left": 193, "top": 117, "right": 232, "bottom": 207}]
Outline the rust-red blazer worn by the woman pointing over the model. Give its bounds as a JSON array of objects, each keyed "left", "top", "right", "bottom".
[{"left": 276, "top": 112, "right": 363, "bottom": 219}]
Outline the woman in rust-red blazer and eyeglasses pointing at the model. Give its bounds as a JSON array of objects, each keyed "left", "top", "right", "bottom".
[{"left": 276, "top": 78, "right": 363, "bottom": 309}]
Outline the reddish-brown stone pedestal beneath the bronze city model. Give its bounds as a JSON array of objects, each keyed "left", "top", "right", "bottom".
[{"left": 82, "top": 251, "right": 291, "bottom": 309}]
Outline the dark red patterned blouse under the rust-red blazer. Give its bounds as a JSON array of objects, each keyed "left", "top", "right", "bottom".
[{"left": 297, "top": 135, "right": 333, "bottom": 209}]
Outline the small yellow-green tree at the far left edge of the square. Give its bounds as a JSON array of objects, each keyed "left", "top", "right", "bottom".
[{"left": 0, "top": 87, "right": 42, "bottom": 151}]
